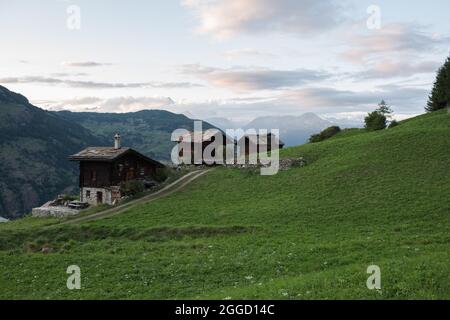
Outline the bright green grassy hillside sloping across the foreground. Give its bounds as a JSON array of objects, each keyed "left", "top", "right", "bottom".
[{"left": 0, "top": 111, "right": 450, "bottom": 299}]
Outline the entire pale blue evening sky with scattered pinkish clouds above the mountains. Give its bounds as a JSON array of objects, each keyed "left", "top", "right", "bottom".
[{"left": 0, "top": 0, "right": 450, "bottom": 121}]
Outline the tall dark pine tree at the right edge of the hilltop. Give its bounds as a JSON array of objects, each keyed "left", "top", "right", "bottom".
[{"left": 425, "top": 56, "right": 450, "bottom": 112}]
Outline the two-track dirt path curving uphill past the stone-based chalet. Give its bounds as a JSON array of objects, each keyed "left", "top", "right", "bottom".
[{"left": 59, "top": 169, "right": 211, "bottom": 225}]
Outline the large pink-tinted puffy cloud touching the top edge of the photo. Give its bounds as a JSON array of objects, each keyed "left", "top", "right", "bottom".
[{"left": 182, "top": 0, "right": 344, "bottom": 38}]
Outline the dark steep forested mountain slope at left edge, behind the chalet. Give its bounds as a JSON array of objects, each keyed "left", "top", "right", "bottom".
[{"left": 0, "top": 86, "right": 104, "bottom": 218}]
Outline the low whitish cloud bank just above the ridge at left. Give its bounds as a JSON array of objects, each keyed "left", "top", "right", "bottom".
[{"left": 40, "top": 96, "right": 175, "bottom": 113}]
